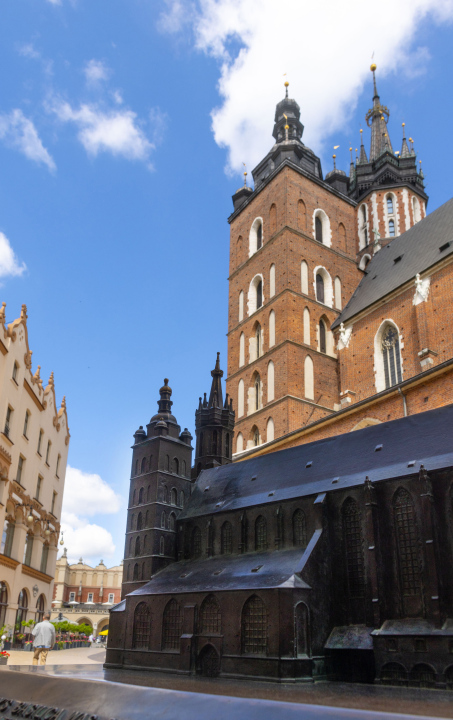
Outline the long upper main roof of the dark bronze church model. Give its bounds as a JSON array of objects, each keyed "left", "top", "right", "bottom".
[{"left": 178, "top": 405, "right": 453, "bottom": 520}]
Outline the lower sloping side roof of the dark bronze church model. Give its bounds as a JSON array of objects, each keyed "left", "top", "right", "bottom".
[{"left": 130, "top": 547, "right": 311, "bottom": 595}]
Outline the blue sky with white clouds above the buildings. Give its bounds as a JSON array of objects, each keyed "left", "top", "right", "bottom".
[{"left": 0, "top": 0, "right": 453, "bottom": 564}]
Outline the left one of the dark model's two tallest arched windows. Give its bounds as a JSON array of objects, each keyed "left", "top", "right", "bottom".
[{"left": 341, "top": 498, "right": 365, "bottom": 598}]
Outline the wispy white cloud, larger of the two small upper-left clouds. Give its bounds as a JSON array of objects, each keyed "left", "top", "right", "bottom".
[{"left": 51, "top": 100, "right": 154, "bottom": 160}]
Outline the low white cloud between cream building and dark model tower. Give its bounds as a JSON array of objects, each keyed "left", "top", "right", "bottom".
[{"left": 61, "top": 465, "right": 122, "bottom": 563}]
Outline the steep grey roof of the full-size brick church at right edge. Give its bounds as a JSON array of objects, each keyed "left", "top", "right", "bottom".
[{"left": 332, "top": 199, "right": 453, "bottom": 329}]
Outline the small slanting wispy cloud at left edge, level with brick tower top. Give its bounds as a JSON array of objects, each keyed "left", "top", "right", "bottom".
[{"left": 0, "top": 109, "right": 56, "bottom": 172}]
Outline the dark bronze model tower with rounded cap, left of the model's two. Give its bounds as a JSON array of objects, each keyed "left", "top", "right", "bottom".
[{"left": 122, "top": 379, "right": 192, "bottom": 597}]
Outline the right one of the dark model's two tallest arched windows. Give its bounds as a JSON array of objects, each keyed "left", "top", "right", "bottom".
[{"left": 393, "top": 488, "right": 421, "bottom": 596}]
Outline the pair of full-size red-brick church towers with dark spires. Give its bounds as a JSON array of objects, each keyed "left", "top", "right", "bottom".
[{"left": 227, "top": 65, "right": 427, "bottom": 453}]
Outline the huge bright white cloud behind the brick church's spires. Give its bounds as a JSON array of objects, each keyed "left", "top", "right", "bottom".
[{"left": 158, "top": 0, "right": 453, "bottom": 172}]
